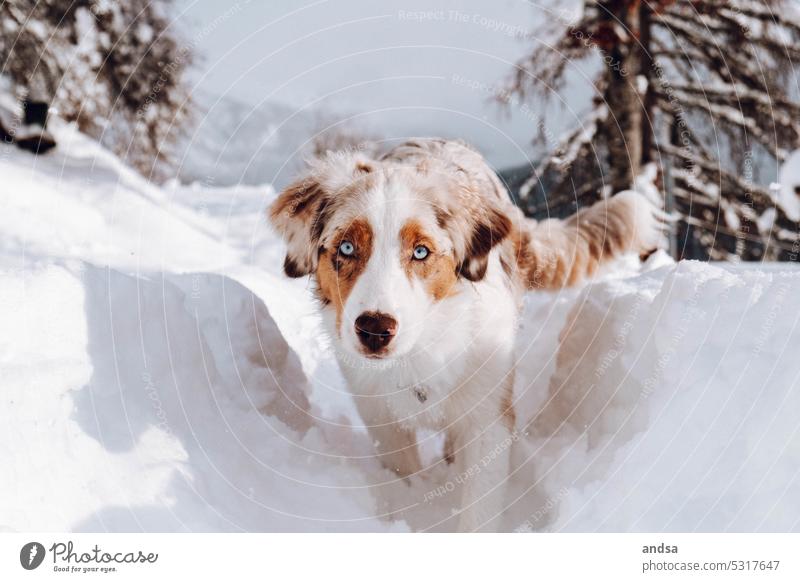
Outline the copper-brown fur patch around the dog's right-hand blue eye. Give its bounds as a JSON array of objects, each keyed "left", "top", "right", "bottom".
[{"left": 400, "top": 220, "right": 457, "bottom": 301}]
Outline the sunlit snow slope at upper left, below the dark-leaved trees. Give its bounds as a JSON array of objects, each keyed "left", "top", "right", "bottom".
[{"left": 0, "top": 127, "right": 239, "bottom": 271}]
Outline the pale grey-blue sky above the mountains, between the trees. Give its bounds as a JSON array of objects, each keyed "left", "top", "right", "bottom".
[{"left": 178, "top": 0, "right": 579, "bottom": 167}]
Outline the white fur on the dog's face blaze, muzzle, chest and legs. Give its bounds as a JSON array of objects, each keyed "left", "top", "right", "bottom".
[{"left": 325, "top": 202, "right": 520, "bottom": 531}]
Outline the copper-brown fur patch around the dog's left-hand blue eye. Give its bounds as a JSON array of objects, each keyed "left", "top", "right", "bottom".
[{"left": 317, "top": 218, "right": 373, "bottom": 329}]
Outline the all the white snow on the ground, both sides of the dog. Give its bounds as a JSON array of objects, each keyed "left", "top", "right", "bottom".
[{"left": 0, "top": 127, "right": 800, "bottom": 531}]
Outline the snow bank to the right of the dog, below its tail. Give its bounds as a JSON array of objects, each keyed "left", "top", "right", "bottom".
[{"left": 509, "top": 262, "right": 800, "bottom": 532}]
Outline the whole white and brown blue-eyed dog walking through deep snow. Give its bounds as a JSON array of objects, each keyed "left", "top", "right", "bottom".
[{"left": 268, "top": 139, "right": 660, "bottom": 531}]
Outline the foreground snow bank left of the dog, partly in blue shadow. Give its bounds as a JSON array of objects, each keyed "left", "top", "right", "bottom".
[{"left": 0, "top": 264, "right": 398, "bottom": 531}]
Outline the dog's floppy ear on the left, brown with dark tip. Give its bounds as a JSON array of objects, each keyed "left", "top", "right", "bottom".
[{"left": 269, "top": 174, "right": 328, "bottom": 277}]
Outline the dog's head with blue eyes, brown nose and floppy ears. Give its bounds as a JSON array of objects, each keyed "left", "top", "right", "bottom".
[{"left": 270, "top": 146, "right": 511, "bottom": 358}]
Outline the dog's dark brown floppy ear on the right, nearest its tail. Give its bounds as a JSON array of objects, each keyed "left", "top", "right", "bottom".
[{"left": 458, "top": 204, "right": 511, "bottom": 281}]
